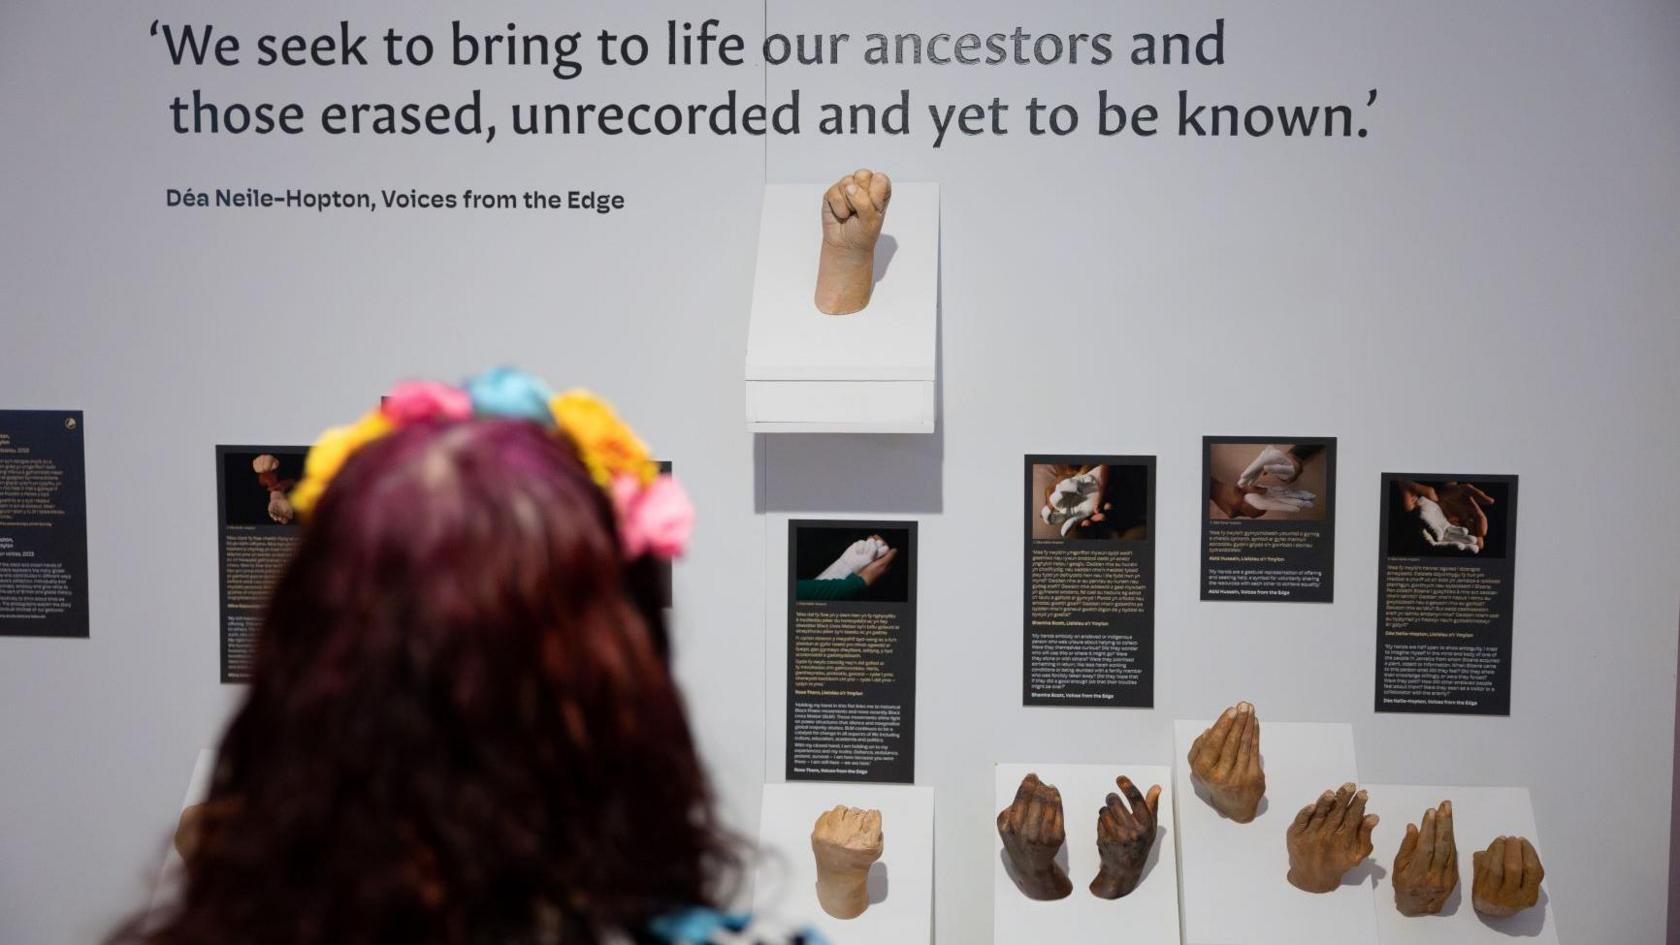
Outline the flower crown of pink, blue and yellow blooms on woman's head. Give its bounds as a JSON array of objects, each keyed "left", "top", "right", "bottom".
[{"left": 291, "top": 368, "right": 694, "bottom": 560}]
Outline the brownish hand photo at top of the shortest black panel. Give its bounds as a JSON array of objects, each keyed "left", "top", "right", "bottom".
[{"left": 1208, "top": 442, "right": 1326, "bottom": 520}]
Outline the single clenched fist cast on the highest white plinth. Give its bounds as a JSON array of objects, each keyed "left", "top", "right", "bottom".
[{"left": 816, "top": 168, "right": 892, "bottom": 314}]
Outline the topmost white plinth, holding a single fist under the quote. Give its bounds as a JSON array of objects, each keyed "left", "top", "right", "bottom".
[{"left": 746, "top": 182, "right": 939, "bottom": 434}]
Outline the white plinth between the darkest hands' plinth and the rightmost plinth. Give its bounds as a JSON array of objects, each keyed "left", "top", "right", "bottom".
[{"left": 1173, "top": 720, "right": 1378, "bottom": 945}]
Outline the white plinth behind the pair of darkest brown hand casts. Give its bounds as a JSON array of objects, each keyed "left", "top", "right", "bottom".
[{"left": 991, "top": 763, "right": 1179, "bottom": 945}]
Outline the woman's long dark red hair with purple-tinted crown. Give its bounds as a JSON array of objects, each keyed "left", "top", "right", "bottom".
[{"left": 123, "top": 420, "right": 738, "bottom": 945}]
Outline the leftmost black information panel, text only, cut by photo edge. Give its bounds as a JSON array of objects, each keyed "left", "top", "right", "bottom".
[{"left": 0, "top": 410, "right": 87, "bottom": 637}]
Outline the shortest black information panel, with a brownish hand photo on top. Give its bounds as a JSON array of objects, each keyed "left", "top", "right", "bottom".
[{"left": 1201, "top": 437, "right": 1336, "bottom": 604}]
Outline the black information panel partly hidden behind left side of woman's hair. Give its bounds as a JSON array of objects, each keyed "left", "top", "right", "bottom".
[{"left": 215, "top": 446, "right": 309, "bottom": 683}]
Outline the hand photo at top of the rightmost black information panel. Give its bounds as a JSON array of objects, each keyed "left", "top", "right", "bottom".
[{"left": 1389, "top": 479, "right": 1504, "bottom": 557}]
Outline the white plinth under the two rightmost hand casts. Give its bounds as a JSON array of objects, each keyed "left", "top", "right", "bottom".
[{"left": 1368, "top": 784, "right": 1557, "bottom": 945}]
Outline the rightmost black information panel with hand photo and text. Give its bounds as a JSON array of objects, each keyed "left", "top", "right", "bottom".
[{"left": 1376, "top": 473, "right": 1517, "bottom": 715}]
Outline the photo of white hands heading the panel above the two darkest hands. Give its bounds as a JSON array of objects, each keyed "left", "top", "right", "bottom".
[{"left": 1032, "top": 462, "right": 1149, "bottom": 540}]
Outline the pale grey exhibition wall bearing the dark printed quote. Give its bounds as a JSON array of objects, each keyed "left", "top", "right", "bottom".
[{"left": 0, "top": 0, "right": 1680, "bottom": 945}]
